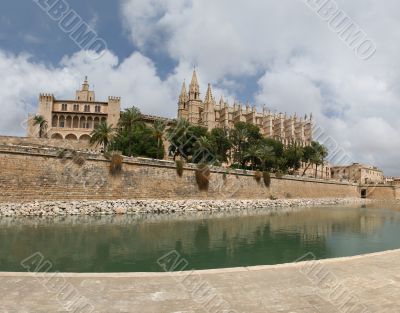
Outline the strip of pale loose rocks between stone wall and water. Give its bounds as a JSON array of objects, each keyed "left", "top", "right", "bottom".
[{"left": 0, "top": 198, "right": 368, "bottom": 217}]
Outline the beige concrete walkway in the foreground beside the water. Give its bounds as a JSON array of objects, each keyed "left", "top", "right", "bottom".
[{"left": 0, "top": 250, "right": 400, "bottom": 313}]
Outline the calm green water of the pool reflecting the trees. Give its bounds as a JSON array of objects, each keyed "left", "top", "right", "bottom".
[{"left": 0, "top": 207, "right": 400, "bottom": 272}]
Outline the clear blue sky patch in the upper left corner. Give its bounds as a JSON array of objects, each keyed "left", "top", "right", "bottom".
[{"left": 0, "top": 0, "right": 128, "bottom": 66}]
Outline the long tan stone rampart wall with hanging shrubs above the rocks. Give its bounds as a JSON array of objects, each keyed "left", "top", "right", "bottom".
[{"left": 0, "top": 144, "right": 368, "bottom": 202}]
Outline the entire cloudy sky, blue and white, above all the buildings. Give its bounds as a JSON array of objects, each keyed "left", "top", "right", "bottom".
[{"left": 0, "top": 0, "right": 400, "bottom": 176}]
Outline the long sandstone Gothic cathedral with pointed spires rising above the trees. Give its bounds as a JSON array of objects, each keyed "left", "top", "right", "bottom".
[{"left": 178, "top": 71, "right": 313, "bottom": 146}]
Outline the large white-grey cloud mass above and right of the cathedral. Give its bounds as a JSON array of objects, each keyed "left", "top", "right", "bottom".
[{"left": 122, "top": 0, "right": 400, "bottom": 175}]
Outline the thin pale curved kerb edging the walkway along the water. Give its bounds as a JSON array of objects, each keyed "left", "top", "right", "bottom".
[{"left": 0, "top": 249, "right": 400, "bottom": 278}]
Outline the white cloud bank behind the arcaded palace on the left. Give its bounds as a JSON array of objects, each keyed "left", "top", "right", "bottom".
[{"left": 0, "top": 51, "right": 178, "bottom": 135}]
